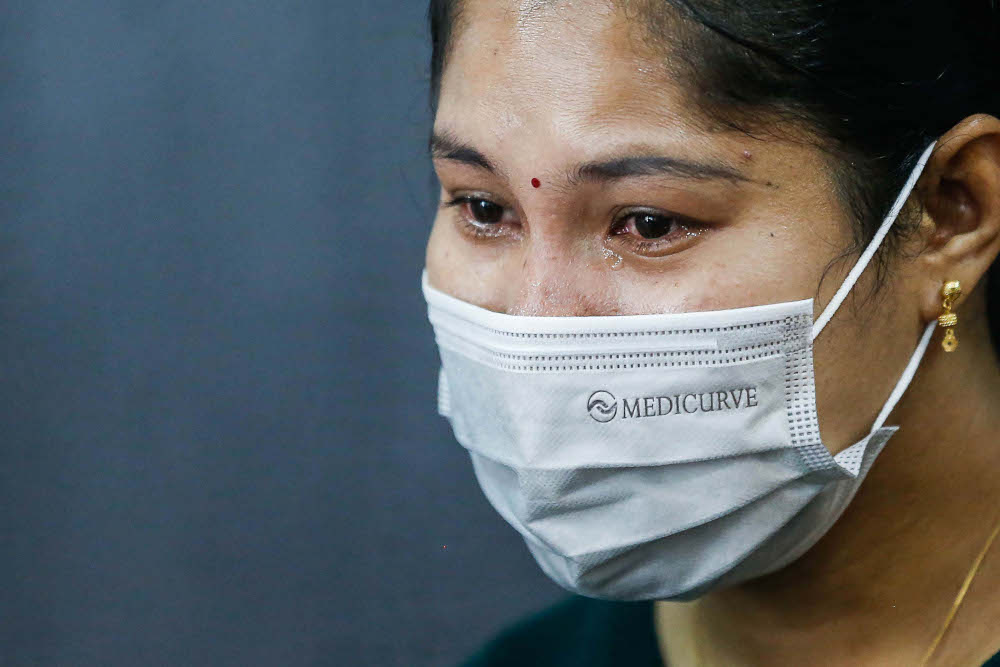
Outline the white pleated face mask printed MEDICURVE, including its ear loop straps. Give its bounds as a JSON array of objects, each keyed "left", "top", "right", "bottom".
[{"left": 423, "top": 144, "right": 934, "bottom": 600}]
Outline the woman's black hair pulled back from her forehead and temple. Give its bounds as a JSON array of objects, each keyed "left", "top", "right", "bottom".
[{"left": 428, "top": 0, "right": 1000, "bottom": 348}]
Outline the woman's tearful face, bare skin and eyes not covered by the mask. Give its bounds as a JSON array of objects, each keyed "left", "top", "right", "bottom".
[{"left": 427, "top": 0, "right": 921, "bottom": 452}]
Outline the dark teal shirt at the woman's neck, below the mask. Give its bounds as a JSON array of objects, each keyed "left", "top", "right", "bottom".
[{"left": 462, "top": 596, "right": 1000, "bottom": 667}]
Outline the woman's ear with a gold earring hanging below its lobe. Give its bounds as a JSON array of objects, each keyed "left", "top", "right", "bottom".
[{"left": 918, "top": 114, "right": 1000, "bottom": 321}]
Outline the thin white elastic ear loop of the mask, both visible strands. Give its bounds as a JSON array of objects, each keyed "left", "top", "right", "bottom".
[{"left": 812, "top": 141, "right": 937, "bottom": 432}]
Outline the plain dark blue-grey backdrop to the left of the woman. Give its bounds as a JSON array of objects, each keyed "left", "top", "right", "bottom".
[{"left": 0, "top": 0, "right": 561, "bottom": 666}]
